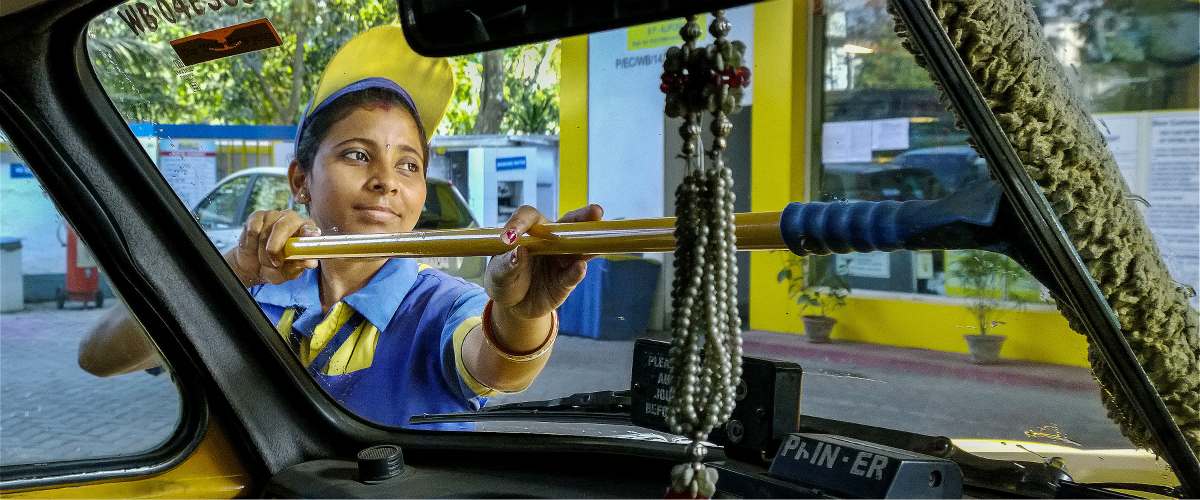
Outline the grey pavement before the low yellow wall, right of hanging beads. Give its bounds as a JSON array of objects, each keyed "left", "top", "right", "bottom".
[{"left": 743, "top": 331, "right": 1132, "bottom": 448}]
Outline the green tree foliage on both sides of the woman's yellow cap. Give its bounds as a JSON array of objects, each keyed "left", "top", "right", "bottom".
[{"left": 88, "top": 0, "right": 559, "bottom": 134}]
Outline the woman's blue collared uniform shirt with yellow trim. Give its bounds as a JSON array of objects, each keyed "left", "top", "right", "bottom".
[{"left": 250, "top": 259, "right": 496, "bottom": 429}]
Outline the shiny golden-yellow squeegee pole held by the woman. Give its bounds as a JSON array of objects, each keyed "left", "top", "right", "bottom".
[{"left": 283, "top": 212, "right": 787, "bottom": 260}]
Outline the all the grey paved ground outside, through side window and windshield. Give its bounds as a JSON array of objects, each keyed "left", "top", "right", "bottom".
[{"left": 0, "top": 299, "right": 1129, "bottom": 464}]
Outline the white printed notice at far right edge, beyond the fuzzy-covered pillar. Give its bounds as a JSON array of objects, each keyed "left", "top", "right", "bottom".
[{"left": 1146, "top": 112, "right": 1200, "bottom": 306}]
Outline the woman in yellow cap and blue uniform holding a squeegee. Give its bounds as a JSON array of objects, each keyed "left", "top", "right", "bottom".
[{"left": 80, "top": 26, "right": 602, "bottom": 428}]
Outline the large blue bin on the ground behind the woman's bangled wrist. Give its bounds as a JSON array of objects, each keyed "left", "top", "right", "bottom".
[{"left": 558, "top": 255, "right": 662, "bottom": 341}]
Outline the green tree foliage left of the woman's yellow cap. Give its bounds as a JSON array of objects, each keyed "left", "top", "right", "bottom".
[{"left": 88, "top": 0, "right": 396, "bottom": 125}]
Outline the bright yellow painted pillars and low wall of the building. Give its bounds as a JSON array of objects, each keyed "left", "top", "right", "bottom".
[{"left": 559, "top": 0, "right": 1087, "bottom": 366}]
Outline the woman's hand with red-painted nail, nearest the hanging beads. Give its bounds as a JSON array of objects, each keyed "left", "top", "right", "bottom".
[{"left": 484, "top": 204, "right": 604, "bottom": 320}]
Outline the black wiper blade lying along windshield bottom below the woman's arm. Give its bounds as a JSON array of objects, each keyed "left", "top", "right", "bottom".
[{"left": 408, "top": 391, "right": 632, "bottom": 426}]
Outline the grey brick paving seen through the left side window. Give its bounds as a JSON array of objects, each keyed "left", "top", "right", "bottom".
[{"left": 0, "top": 301, "right": 179, "bottom": 464}]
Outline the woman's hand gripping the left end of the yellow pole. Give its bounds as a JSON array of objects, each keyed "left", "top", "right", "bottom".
[{"left": 224, "top": 210, "right": 320, "bottom": 287}]
